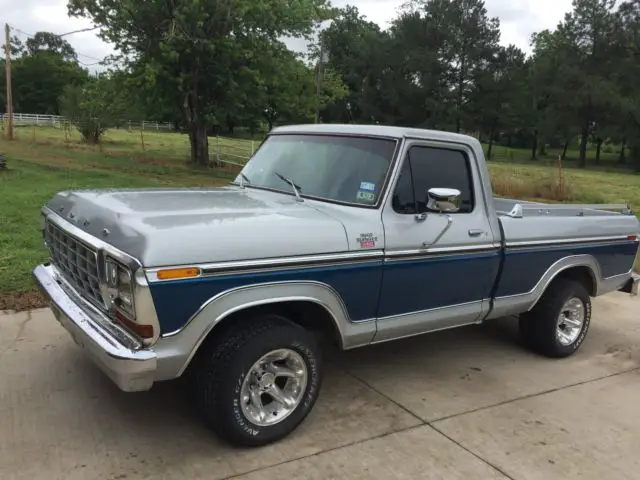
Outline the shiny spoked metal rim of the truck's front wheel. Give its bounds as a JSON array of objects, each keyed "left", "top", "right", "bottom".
[{"left": 240, "top": 348, "right": 308, "bottom": 427}]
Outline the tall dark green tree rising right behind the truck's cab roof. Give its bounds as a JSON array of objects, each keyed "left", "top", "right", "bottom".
[{"left": 389, "top": 0, "right": 500, "bottom": 132}]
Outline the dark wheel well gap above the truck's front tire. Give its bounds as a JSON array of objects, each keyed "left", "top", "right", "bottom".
[{"left": 198, "top": 300, "right": 342, "bottom": 350}]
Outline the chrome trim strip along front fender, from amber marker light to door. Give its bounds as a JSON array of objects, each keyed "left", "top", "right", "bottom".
[{"left": 145, "top": 250, "right": 383, "bottom": 283}]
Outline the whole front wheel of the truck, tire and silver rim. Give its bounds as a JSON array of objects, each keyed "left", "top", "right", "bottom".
[{"left": 193, "top": 315, "right": 322, "bottom": 446}]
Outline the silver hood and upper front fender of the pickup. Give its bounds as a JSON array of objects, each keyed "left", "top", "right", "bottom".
[{"left": 47, "top": 186, "right": 349, "bottom": 267}]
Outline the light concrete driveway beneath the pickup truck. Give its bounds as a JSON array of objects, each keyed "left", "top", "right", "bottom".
[{"left": 0, "top": 294, "right": 640, "bottom": 480}]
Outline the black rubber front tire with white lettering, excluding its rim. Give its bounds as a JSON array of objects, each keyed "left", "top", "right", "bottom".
[{"left": 189, "top": 314, "right": 323, "bottom": 447}]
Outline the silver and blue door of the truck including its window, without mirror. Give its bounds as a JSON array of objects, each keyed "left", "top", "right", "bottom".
[{"left": 374, "top": 140, "right": 499, "bottom": 341}]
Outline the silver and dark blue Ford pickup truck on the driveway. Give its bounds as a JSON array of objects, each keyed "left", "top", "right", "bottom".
[{"left": 33, "top": 125, "right": 640, "bottom": 446}]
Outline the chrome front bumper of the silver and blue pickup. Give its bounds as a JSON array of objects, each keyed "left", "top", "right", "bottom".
[{"left": 33, "top": 265, "right": 157, "bottom": 392}]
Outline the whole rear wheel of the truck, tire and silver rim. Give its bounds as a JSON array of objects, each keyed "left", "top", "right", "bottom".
[{"left": 520, "top": 278, "right": 591, "bottom": 358}]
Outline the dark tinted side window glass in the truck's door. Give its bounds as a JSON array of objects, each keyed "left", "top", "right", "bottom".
[{"left": 393, "top": 146, "right": 474, "bottom": 214}]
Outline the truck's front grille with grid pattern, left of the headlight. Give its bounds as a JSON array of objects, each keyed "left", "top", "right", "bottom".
[{"left": 45, "top": 222, "right": 104, "bottom": 308}]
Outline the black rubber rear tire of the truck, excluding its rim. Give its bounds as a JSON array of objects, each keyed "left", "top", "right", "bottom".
[{"left": 520, "top": 278, "right": 591, "bottom": 358}]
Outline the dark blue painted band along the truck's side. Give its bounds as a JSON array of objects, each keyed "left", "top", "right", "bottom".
[{"left": 151, "top": 242, "right": 637, "bottom": 333}]
